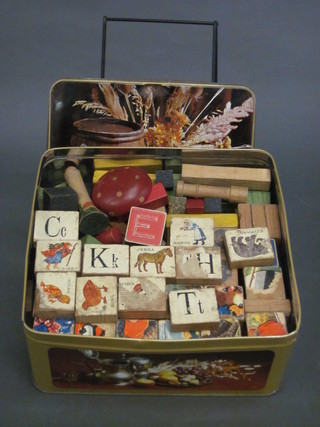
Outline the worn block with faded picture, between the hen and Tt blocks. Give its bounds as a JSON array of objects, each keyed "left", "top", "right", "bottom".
[{"left": 118, "top": 277, "right": 167, "bottom": 319}]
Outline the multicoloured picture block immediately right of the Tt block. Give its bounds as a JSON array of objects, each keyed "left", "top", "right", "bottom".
[{"left": 214, "top": 285, "right": 244, "bottom": 320}]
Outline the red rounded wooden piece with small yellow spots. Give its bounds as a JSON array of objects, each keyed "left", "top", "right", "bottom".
[{"left": 92, "top": 166, "right": 152, "bottom": 216}]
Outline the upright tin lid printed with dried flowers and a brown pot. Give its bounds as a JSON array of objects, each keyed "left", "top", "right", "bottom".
[{"left": 48, "top": 80, "right": 255, "bottom": 149}]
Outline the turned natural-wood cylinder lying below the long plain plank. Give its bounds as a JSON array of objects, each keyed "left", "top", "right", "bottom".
[{"left": 176, "top": 180, "right": 248, "bottom": 203}]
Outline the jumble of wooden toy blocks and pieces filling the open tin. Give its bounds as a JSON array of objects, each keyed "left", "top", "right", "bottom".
[{"left": 33, "top": 159, "right": 291, "bottom": 340}]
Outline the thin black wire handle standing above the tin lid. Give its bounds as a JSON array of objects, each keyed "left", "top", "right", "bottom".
[{"left": 101, "top": 16, "right": 218, "bottom": 83}]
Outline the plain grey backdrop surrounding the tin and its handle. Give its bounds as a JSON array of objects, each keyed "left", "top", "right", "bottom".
[{"left": 0, "top": 0, "right": 320, "bottom": 427}]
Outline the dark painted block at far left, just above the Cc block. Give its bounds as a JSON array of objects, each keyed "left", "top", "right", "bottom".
[{"left": 43, "top": 186, "right": 79, "bottom": 211}]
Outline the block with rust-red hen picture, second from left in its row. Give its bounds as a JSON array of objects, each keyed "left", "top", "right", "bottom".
[{"left": 75, "top": 276, "right": 118, "bottom": 323}]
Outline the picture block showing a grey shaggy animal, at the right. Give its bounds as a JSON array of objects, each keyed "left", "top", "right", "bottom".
[{"left": 225, "top": 227, "right": 275, "bottom": 268}]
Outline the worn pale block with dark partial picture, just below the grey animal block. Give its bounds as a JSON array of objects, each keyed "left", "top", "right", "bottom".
[{"left": 243, "top": 267, "right": 286, "bottom": 300}]
